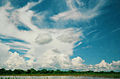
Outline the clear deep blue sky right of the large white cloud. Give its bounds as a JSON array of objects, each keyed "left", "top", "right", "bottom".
[{"left": 71, "top": 0, "right": 120, "bottom": 64}]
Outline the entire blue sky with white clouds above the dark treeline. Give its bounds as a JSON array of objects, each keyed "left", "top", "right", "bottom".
[{"left": 0, "top": 0, "right": 120, "bottom": 71}]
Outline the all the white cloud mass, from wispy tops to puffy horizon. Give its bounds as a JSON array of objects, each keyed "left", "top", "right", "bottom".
[{"left": 0, "top": 0, "right": 120, "bottom": 71}]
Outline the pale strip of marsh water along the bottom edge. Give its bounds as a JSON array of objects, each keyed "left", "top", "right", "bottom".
[{"left": 0, "top": 76, "right": 120, "bottom": 79}]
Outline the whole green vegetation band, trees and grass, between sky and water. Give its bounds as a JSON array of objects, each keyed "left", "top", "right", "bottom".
[{"left": 0, "top": 68, "right": 120, "bottom": 78}]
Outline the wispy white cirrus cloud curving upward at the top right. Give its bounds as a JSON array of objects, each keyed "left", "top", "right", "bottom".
[{"left": 51, "top": 0, "right": 105, "bottom": 21}]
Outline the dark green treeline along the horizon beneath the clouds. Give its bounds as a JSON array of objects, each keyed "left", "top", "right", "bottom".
[{"left": 0, "top": 68, "right": 120, "bottom": 75}]
